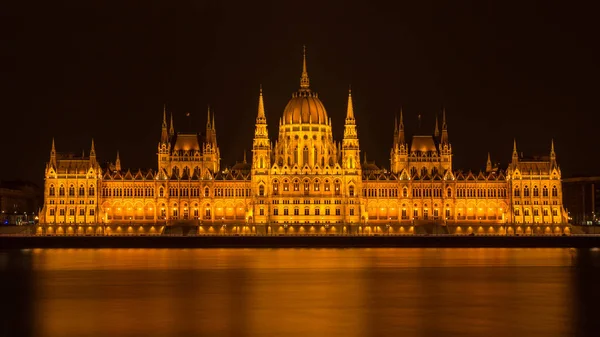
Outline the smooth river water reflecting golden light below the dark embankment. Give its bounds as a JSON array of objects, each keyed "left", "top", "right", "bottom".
[{"left": 0, "top": 248, "right": 600, "bottom": 337}]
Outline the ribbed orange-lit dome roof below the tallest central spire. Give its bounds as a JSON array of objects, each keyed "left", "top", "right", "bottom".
[{"left": 283, "top": 90, "right": 327, "bottom": 124}]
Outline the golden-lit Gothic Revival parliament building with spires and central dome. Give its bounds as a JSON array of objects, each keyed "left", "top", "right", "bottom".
[{"left": 40, "top": 49, "right": 568, "bottom": 235}]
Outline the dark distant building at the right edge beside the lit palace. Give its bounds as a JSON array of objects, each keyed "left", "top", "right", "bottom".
[{"left": 563, "top": 177, "right": 600, "bottom": 225}]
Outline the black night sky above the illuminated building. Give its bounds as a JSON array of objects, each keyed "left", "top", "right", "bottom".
[{"left": 0, "top": 1, "right": 600, "bottom": 183}]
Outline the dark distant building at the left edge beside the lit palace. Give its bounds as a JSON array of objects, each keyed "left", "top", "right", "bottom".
[{"left": 0, "top": 180, "right": 42, "bottom": 225}]
